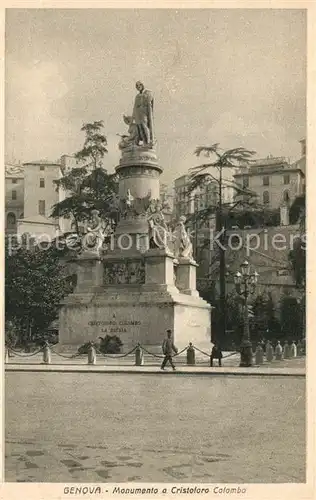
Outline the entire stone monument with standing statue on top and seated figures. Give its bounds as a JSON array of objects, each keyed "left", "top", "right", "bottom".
[{"left": 60, "top": 82, "right": 211, "bottom": 352}]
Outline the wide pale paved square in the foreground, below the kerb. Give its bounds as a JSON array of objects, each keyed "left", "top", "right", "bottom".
[{"left": 5, "top": 372, "right": 305, "bottom": 483}]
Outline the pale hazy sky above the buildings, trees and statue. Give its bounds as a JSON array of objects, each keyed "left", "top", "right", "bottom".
[{"left": 5, "top": 9, "right": 306, "bottom": 183}]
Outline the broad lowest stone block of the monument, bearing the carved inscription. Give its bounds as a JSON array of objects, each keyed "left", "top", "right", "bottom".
[{"left": 60, "top": 285, "right": 211, "bottom": 353}]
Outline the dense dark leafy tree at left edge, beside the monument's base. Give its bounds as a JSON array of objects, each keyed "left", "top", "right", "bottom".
[{"left": 5, "top": 240, "right": 73, "bottom": 344}]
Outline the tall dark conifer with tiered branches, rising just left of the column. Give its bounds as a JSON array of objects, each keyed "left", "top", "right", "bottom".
[{"left": 51, "top": 121, "right": 118, "bottom": 233}]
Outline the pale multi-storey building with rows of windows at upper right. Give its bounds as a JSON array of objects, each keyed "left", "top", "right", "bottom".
[{"left": 234, "top": 152, "right": 305, "bottom": 209}]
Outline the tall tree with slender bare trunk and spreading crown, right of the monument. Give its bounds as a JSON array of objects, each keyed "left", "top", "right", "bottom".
[{"left": 188, "top": 144, "right": 257, "bottom": 344}]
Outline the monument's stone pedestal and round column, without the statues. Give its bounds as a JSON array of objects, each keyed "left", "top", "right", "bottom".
[{"left": 60, "top": 134, "right": 211, "bottom": 354}]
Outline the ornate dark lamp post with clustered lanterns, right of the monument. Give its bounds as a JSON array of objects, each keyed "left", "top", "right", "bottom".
[{"left": 234, "top": 261, "right": 259, "bottom": 366}]
